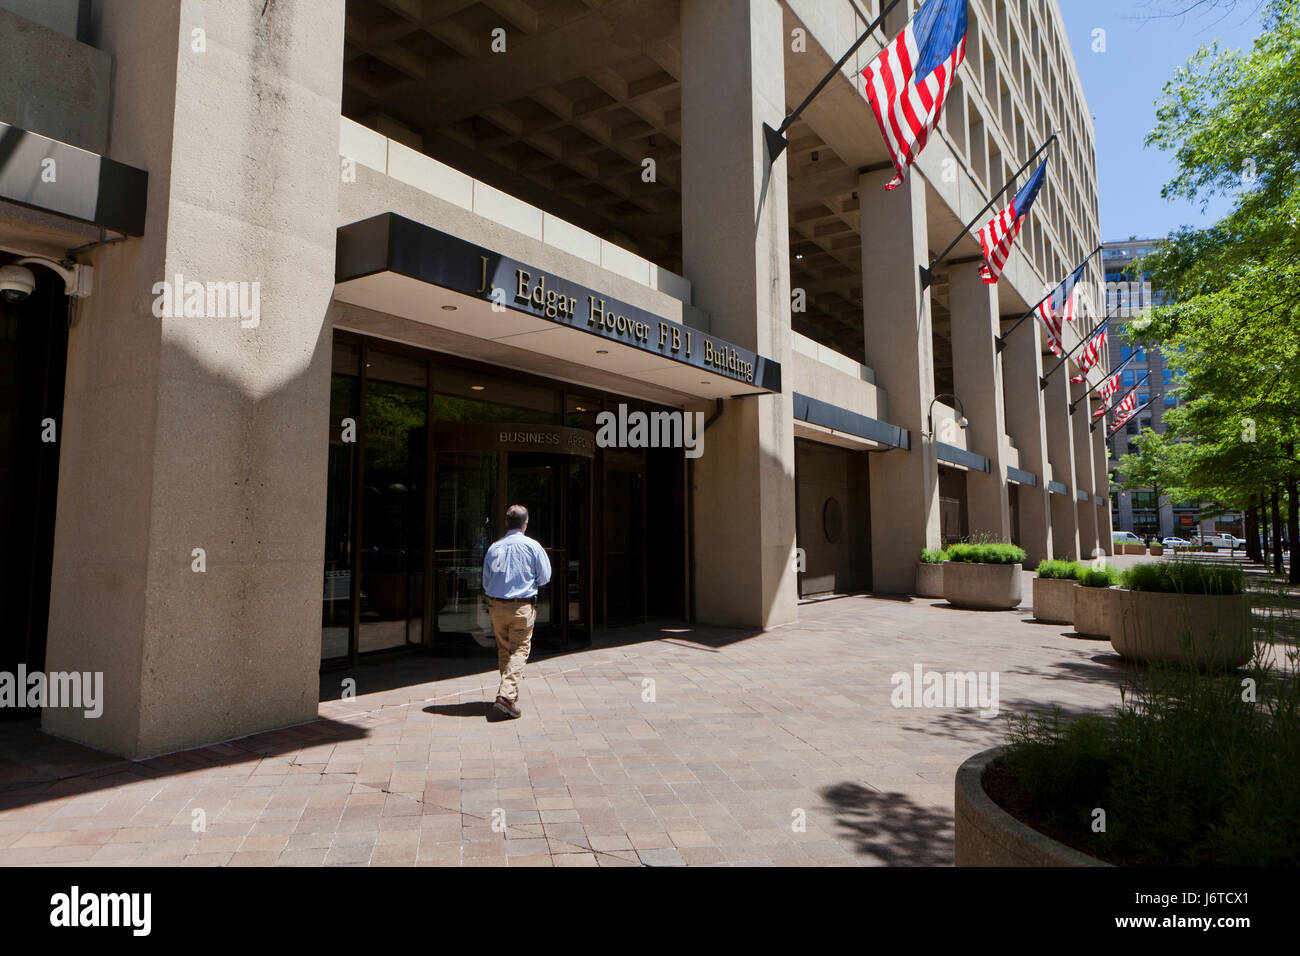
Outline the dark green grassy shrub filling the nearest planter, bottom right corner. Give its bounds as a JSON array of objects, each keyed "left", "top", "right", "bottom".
[{"left": 1002, "top": 658, "right": 1300, "bottom": 866}]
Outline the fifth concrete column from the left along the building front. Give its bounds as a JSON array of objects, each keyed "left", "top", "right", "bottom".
[{"left": 998, "top": 316, "right": 1052, "bottom": 567}]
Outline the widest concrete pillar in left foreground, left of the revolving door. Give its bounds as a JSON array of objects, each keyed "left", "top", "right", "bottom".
[{"left": 43, "top": 0, "right": 345, "bottom": 757}]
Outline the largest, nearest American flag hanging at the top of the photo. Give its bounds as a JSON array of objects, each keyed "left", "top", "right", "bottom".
[{"left": 862, "top": 0, "right": 967, "bottom": 189}]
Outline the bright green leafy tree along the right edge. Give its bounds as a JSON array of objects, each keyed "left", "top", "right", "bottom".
[{"left": 1128, "top": 0, "right": 1300, "bottom": 581}]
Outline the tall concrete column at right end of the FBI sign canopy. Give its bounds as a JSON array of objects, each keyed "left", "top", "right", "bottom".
[{"left": 681, "top": 0, "right": 798, "bottom": 627}]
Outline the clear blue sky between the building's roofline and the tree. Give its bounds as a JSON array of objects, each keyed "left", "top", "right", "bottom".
[{"left": 1060, "top": 0, "right": 1261, "bottom": 239}]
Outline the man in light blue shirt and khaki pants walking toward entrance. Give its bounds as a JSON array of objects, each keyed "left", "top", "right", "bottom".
[{"left": 484, "top": 505, "right": 551, "bottom": 717}]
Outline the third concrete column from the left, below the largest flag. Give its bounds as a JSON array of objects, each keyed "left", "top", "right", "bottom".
[{"left": 858, "top": 169, "right": 940, "bottom": 594}]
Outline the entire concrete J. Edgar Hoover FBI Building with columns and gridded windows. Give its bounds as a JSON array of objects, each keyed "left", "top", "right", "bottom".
[{"left": 0, "top": 0, "right": 1110, "bottom": 756}]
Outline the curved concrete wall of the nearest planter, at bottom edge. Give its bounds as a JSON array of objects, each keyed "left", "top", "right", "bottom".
[{"left": 953, "top": 747, "right": 1110, "bottom": 866}]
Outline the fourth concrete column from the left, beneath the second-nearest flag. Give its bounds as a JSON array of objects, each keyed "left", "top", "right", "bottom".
[{"left": 940, "top": 263, "right": 1011, "bottom": 541}]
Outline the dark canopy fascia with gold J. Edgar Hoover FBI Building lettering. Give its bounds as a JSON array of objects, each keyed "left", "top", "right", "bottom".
[{"left": 335, "top": 212, "right": 781, "bottom": 392}]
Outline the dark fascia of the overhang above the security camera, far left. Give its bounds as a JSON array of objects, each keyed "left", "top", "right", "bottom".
[{"left": 0, "top": 122, "right": 150, "bottom": 235}]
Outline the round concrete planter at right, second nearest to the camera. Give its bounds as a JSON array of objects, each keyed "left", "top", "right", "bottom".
[{"left": 1110, "top": 588, "right": 1255, "bottom": 667}]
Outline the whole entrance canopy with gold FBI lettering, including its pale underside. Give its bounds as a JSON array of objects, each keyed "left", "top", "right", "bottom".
[{"left": 334, "top": 212, "right": 781, "bottom": 399}]
